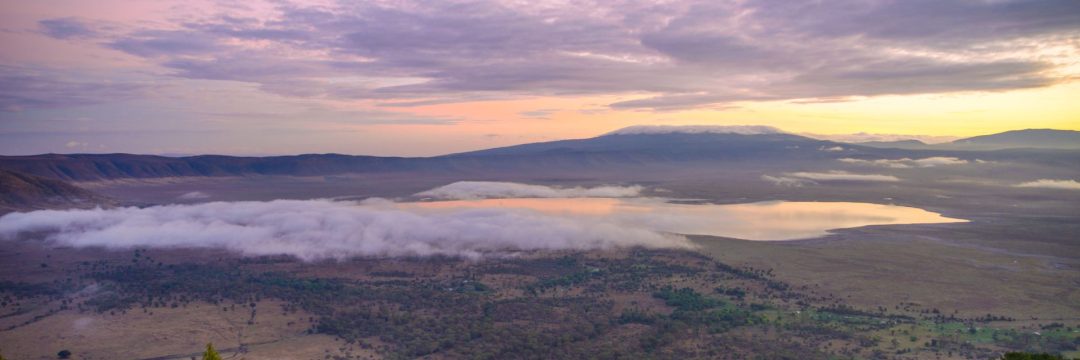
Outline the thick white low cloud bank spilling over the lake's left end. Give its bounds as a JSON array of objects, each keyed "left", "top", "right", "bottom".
[{"left": 0, "top": 200, "right": 692, "bottom": 261}]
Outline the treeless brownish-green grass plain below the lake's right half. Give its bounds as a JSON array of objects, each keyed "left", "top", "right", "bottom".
[{"left": 696, "top": 235, "right": 1080, "bottom": 319}]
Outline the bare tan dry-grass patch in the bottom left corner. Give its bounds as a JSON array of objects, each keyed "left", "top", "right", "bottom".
[{"left": 0, "top": 301, "right": 377, "bottom": 360}]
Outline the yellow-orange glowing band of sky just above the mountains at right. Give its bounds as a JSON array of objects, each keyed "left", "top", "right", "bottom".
[{"left": 388, "top": 83, "right": 1080, "bottom": 148}]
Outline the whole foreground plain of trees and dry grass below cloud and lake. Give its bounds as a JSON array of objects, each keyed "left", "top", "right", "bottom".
[{"left": 0, "top": 239, "right": 1078, "bottom": 359}]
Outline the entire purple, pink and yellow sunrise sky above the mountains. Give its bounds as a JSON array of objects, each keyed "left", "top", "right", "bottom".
[{"left": 0, "top": 0, "right": 1080, "bottom": 156}]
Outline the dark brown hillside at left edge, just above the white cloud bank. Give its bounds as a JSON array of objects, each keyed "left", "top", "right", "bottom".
[{"left": 0, "top": 170, "right": 111, "bottom": 214}]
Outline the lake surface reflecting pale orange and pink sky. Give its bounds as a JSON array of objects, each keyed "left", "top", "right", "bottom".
[{"left": 397, "top": 198, "right": 967, "bottom": 241}]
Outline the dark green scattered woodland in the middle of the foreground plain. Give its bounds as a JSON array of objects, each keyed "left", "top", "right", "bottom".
[{"left": 73, "top": 251, "right": 816, "bottom": 358}]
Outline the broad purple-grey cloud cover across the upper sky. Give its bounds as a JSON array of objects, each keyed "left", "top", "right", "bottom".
[{"left": 16, "top": 0, "right": 1080, "bottom": 110}]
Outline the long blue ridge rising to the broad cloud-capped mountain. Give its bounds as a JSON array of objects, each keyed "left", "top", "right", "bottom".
[{"left": 0, "top": 126, "right": 841, "bottom": 182}]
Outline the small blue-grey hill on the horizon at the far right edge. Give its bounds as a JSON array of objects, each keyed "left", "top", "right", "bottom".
[{"left": 949, "top": 129, "right": 1080, "bottom": 149}]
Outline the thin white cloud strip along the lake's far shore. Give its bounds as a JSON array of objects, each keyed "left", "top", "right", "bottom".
[{"left": 416, "top": 182, "right": 643, "bottom": 200}]
